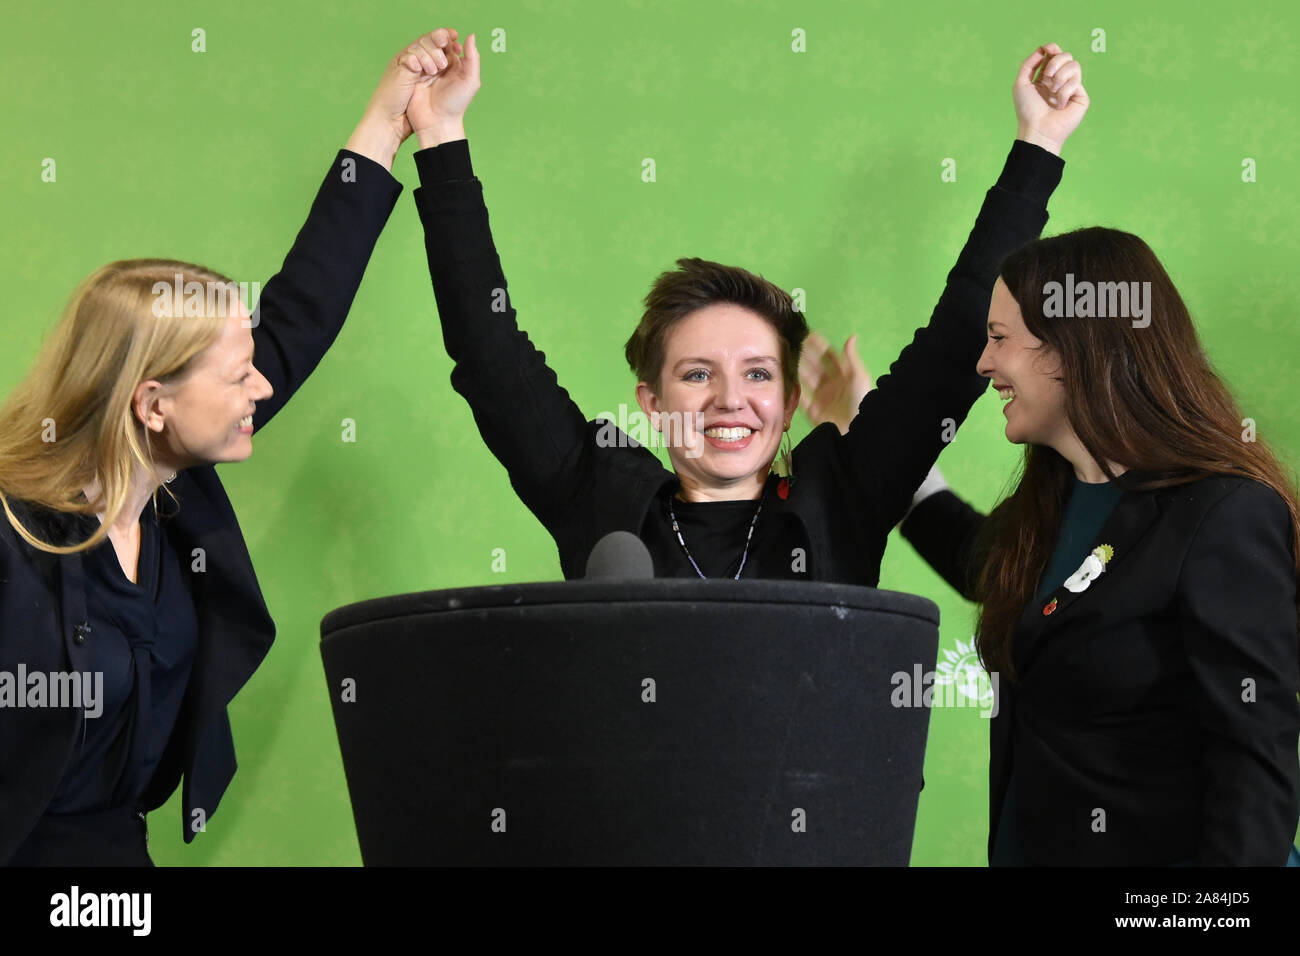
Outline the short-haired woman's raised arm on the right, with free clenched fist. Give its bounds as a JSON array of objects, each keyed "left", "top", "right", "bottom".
[{"left": 840, "top": 44, "right": 1088, "bottom": 528}]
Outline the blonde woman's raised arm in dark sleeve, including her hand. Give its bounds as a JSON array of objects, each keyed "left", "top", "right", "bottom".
[{"left": 251, "top": 30, "right": 467, "bottom": 431}]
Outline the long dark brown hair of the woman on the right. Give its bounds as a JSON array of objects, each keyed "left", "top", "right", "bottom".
[{"left": 976, "top": 228, "right": 1300, "bottom": 680}]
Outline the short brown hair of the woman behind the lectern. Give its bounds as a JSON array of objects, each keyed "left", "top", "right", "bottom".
[{"left": 624, "top": 259, "right": 809, "bottom": 395}]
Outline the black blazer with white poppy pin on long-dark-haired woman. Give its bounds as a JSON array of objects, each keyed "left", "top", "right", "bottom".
[{"left": 901, "top": 477, "right": 1300, "bottom": 866}]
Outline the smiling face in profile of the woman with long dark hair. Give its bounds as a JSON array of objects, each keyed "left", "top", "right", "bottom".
[{"left": 976, "top": 278, "right": 1078, "bottom": 450}]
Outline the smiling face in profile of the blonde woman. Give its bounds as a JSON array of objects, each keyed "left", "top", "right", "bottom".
[{"left": 134, "top": 303, "right": 272, "bottom": 471}]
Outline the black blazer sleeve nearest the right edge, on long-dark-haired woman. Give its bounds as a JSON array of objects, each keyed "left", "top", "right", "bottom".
[{"left": 1178, "top": 483, "right": 1300, "bottom": 866}]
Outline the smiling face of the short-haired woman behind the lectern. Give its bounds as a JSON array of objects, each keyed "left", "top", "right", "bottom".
[{"left": 637, "top": 303, "right": 800, "bottom": 501}]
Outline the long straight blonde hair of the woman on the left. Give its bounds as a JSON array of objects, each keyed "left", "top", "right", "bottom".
[{"left": 0, "top": 259, "right": 234, "bottom": 554}]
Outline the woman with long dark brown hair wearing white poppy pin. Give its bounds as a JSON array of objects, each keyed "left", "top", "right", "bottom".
[{"left": 805, "top": 228, "right": 1300, "bottom": 865}]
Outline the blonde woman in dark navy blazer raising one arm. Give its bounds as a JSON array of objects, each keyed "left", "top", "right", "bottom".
[{"left": 0, "top": 30, "right": 455, "bottom": 865}]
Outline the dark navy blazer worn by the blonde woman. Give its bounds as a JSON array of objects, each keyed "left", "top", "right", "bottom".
[{"left": 0, "top": 150, "right": 402, "bottom": 862}]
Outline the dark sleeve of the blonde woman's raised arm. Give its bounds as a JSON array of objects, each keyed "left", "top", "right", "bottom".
[{"left": 252, "top": 150, "right": 402, "bottom": 432}]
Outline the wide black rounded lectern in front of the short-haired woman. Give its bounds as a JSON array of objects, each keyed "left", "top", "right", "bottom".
[{"left": 321, "top": 579, "right": 939, "bottom": 865}]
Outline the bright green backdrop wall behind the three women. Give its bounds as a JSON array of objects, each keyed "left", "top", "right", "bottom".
[{"left": 0, "top": 0, "right": 1300, "bottom": 865}]
